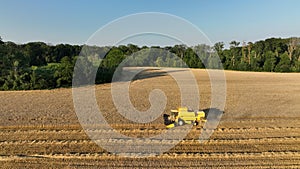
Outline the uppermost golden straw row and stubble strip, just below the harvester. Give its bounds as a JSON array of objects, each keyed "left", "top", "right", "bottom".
[{"left": 0, "top": 127, "right": 300, "bottom": 142}]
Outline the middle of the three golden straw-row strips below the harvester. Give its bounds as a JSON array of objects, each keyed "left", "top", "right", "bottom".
[{"left": 0, "top": 137, "right": 300, "bottom": 154}]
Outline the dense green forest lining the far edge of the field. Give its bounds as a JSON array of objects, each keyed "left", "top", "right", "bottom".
[{"left": 0, "top": 37, "right": 300, "bottom": 90}]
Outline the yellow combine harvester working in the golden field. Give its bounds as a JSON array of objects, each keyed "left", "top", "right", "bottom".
[{"left": 164, "top": 107, "right": 206, "bottom": 128}]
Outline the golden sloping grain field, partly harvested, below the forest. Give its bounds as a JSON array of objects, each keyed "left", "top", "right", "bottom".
[{"left": 0, "top": 70, "right": 300, "bottom": 168}]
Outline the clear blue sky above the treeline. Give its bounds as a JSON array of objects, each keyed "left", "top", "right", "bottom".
[{"left": 0, "top": 0, "right": 300, "bottom": 44}]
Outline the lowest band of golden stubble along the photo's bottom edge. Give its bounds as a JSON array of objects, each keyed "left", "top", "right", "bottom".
[{"left": 0, "top": 152, "right": 300, "bottom": 169}]
